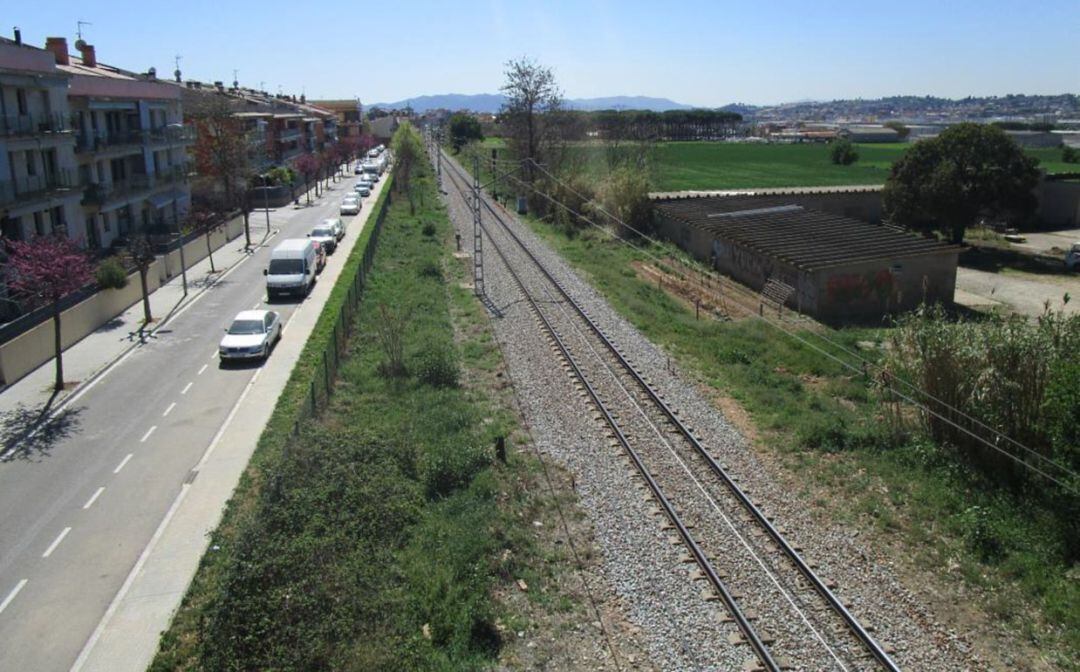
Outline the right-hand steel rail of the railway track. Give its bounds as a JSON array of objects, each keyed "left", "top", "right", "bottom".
[{"left": 438, "top": 152, "right": 901, "bottom": 672}]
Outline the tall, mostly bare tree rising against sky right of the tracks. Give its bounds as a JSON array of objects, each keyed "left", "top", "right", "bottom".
[{"left": 500, "top": 57, "right": 563, "bottom": 182}]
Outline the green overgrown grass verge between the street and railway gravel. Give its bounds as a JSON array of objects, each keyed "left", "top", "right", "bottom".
[{"left": 151, "top": 160, "right": 583, "bottom": 671}]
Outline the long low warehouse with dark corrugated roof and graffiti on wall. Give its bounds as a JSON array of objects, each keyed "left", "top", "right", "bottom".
[{"left": 657, "top": 196, "right": 960, "bottom": 322}]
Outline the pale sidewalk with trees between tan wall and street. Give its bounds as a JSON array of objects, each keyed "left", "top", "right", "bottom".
[{"left": 0, "top": 179, "right": 333, "bottom": 460}]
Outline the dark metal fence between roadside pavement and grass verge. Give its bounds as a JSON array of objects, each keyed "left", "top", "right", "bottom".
[{"left": 285, "top": 184, "right": 391, "bottom": 436}]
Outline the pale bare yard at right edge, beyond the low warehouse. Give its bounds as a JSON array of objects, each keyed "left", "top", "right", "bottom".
[{"left": 955, "top": 267, "right": 1080, "bottom": 317}]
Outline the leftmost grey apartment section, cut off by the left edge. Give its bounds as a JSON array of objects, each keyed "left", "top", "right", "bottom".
[{"left": 0, "top": 31, "right": 87, "bottom": 241}]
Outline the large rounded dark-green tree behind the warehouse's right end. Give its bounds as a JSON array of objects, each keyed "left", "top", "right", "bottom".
[{"left": 883, "top": 123, "right": 1039, "bottom": 243}]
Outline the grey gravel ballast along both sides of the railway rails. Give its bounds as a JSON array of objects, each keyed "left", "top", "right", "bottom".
[{"left": 432, "top": 152, "right": 981, "bottom": 670}]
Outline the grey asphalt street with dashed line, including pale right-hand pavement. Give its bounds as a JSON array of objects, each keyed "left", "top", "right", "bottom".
[{"left": 0, "top": 169, "right": 384, "bottom": 671}]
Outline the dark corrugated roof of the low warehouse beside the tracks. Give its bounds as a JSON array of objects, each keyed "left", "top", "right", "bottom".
[{"left": 657, "top": 197, "right": 960, "bottom": 271}]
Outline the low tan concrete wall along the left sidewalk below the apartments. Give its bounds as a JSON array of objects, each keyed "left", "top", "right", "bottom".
[{"left": 0, "top": 217, "right": 244, "bottom": 385}]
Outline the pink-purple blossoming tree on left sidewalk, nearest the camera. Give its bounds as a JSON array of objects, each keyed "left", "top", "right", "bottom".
[{"left": 6, "top": 234, "right": 94, "bottom": 391}]
